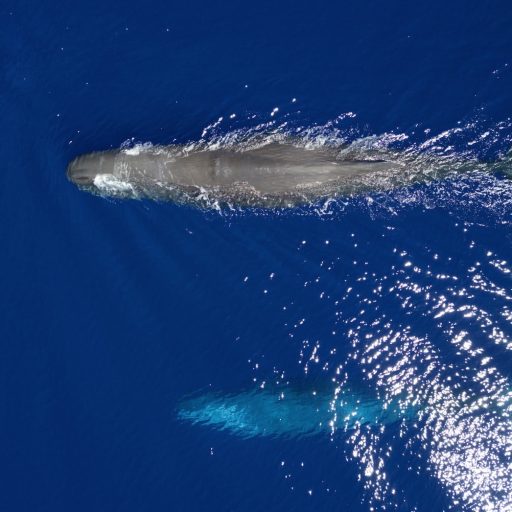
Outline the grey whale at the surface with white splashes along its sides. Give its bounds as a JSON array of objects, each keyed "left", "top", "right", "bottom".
[{"left": 67, "top": 142, "right": 397, "bottom": 206}]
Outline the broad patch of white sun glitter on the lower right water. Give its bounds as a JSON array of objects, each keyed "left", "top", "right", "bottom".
[{"left": 244, "top": 176, "right": 512, "bottom": 511}]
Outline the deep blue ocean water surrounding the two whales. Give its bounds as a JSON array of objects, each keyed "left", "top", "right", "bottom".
[{"left": 0, "top": 0, "right": 512, "bottom": 512}]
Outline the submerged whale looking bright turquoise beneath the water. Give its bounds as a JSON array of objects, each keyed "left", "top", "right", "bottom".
[{"left": 177, "top": 388, "right": 418, "bottom": 438}]
